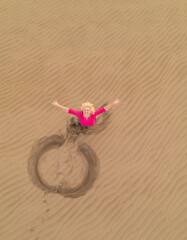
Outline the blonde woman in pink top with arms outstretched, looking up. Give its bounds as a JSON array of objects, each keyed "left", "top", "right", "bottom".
[{"left": 51, "top": 98, "right": 120, "bottom": 126}]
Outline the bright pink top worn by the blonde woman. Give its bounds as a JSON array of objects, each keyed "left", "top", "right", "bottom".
[{"left": 68, "top": 108, "right": 106, "bottom": 126}]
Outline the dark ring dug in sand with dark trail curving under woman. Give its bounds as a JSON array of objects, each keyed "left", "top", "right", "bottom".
[{"left": 28, "top": 103, "right": 110, "bottom": 198}]
